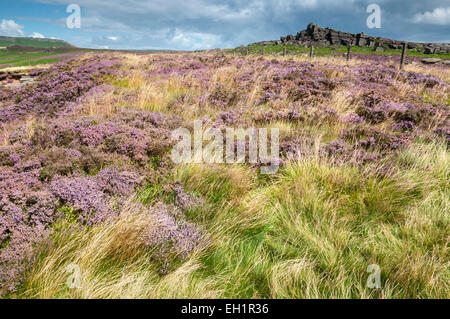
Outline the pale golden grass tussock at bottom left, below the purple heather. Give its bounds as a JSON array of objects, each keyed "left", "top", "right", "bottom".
[{"left": 22, "top": 200, "right": 218, "bottom": 299}]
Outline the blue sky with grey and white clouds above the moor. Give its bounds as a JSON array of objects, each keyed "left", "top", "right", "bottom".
[{"left": 0, "top": 0, "right": 450, "bottom": 50}]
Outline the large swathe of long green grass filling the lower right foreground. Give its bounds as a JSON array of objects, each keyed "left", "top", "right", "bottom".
[{"left": 175, "top": 144, "right": 449, "bottom": 298}]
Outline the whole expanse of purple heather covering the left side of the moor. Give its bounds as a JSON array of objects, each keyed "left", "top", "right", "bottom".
[{"left": 0, "top": 58, "right": 178, "bottom": 293}]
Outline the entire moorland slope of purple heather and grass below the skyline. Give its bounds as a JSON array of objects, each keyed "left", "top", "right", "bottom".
[{"left": 0, "top": 52, "right": 450, "bottom": 298}]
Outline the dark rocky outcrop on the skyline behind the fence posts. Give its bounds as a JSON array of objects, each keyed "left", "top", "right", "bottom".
[{"left": 256, "top": 22, "right": 450, "bottom": 54}]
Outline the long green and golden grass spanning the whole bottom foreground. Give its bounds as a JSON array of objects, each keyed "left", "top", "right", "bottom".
[{"left": 15, "top": 142, "right": 450, "bottom": 298}]
